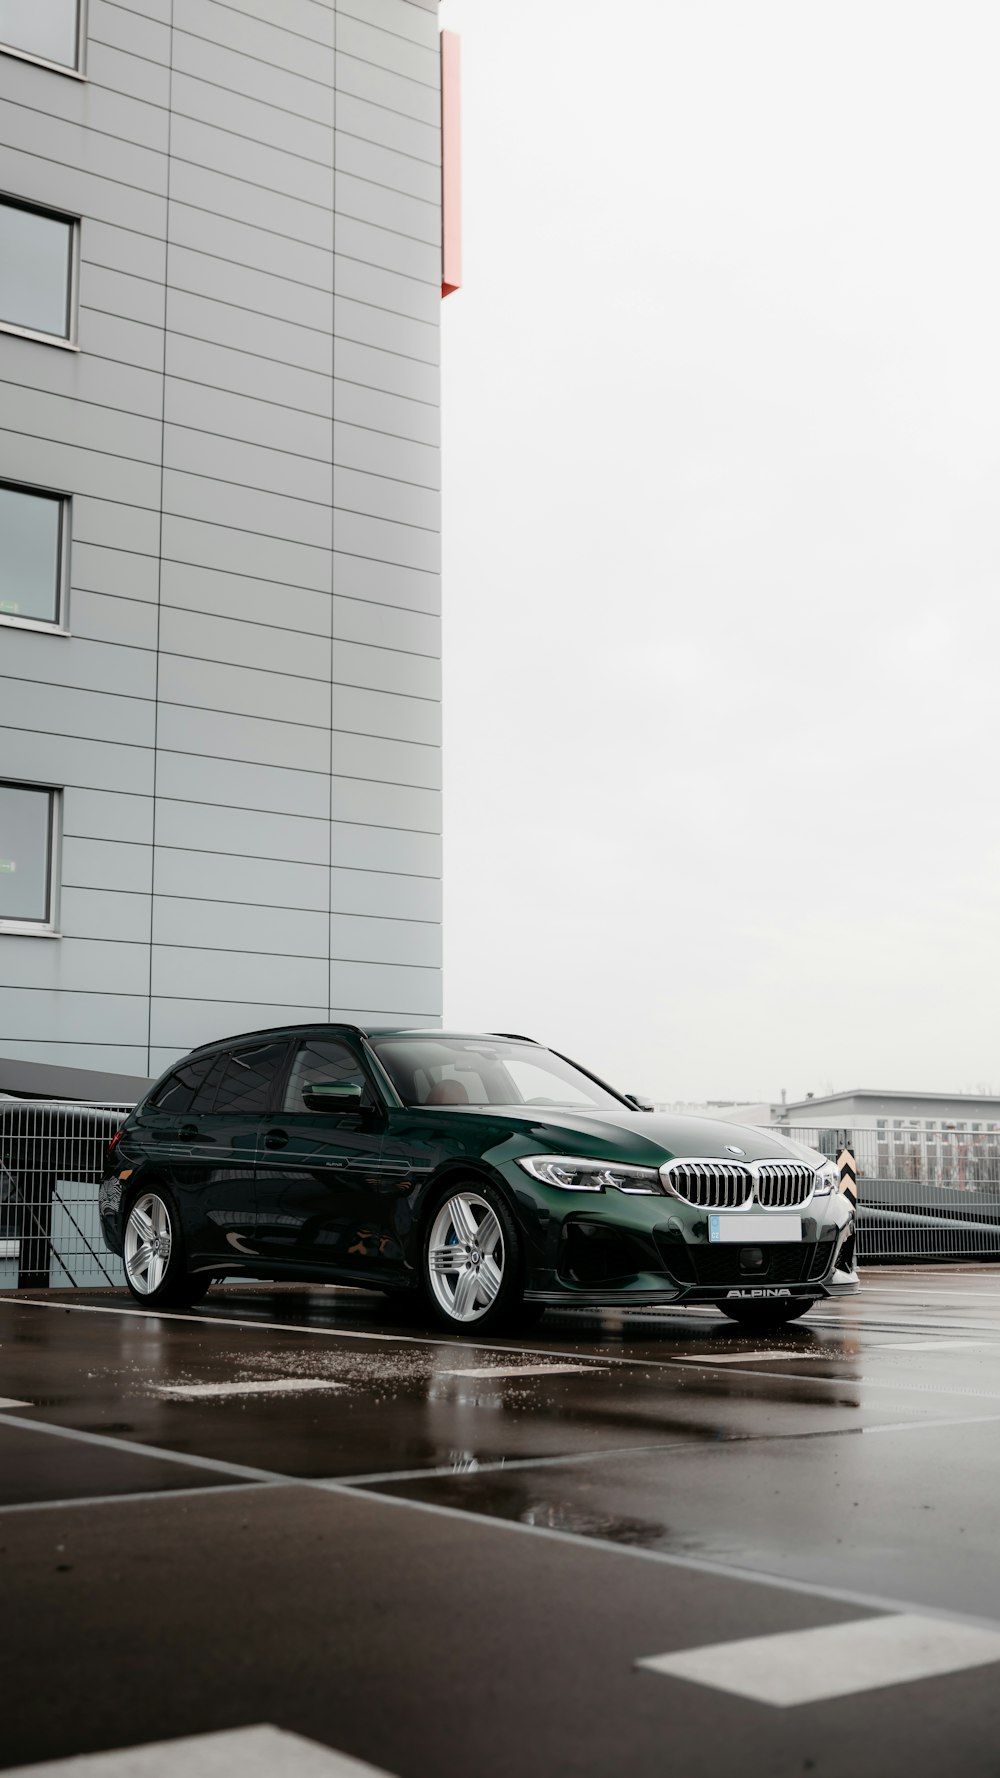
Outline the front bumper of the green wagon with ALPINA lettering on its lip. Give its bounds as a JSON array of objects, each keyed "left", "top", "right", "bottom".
[{"left": 518, "top": 1188, "right": 858, "bottom": 1309}]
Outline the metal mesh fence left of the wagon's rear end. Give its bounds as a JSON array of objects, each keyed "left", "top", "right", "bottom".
[{"left": 0, "top": 1099, "right": 132, "bottom": 1291}]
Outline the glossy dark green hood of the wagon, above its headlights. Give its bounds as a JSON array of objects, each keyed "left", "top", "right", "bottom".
[{"left": 448, "top": 1106, "right": 824, "bottom": 1166}]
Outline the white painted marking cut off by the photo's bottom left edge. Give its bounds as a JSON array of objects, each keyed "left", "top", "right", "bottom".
[{"left": 5, "top": 1723, "right": 391, "bottom": 1778}]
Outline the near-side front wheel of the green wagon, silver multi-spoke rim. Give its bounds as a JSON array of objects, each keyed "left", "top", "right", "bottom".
[{"left": 422, "top": 1181, "right": 525, "bottom": 1334}]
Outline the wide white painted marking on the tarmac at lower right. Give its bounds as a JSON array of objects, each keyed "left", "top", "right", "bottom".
[{"left": 637, "top": 1613, "right": 1000, "bottom": 1709}]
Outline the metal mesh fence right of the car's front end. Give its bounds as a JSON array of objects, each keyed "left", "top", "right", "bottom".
[{"left": 781, "top": 1118, "right": 1000, "bottom": 1262}]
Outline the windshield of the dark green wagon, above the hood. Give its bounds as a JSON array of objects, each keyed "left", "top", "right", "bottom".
[{"left": 372, "top": 1037, "right": 621, "bottom": 1111}]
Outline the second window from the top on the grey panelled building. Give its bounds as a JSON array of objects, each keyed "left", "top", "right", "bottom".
[{"left": 0, "top": 197, "right": 77, "bottom": 345}]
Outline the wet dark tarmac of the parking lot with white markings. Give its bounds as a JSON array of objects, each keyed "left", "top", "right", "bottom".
[{"left": 0, "top": 1266, "right": 1000, "bottom": 1778}]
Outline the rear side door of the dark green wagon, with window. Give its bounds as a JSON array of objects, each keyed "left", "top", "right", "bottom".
[{"left": 149, "top": 1040, "right": 288, "bottom": 1271}]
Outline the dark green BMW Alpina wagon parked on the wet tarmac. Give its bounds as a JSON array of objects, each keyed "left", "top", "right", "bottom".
[{"left": 101, "top": 1024, "right": 858, "bottom": 1332}]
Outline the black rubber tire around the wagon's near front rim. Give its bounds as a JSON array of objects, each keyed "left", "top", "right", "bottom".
[{"left": 420, "top": 1179, "right": 539, "bottom": 1335}]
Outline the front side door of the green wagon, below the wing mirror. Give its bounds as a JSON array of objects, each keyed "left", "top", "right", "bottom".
[{"left": 256, "top": 1033, "right": 386, "bottom": 1280}]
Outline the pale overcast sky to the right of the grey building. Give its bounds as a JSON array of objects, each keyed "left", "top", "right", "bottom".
[{"left": 441, "top": 0, "right": 1000, "bottom": 1099}]
